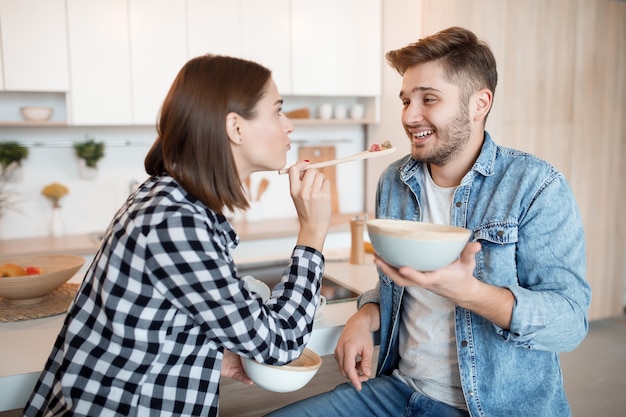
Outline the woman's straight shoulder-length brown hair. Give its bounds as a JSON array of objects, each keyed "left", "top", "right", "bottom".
[{"left": 144, "top": 55, "right": 271, "bottom": 213}]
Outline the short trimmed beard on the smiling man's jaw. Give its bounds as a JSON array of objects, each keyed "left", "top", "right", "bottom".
[{"left": 409, "top": 105, "right": 471, "bottom": 165}]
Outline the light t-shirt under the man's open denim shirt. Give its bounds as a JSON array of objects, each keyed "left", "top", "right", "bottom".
[{"left": 394, "top": 164, "right": 466, "bottom": 409}]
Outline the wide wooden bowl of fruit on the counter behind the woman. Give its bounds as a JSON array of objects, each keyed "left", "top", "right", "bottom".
[{"left": 0, "top": 255, "right": 85, "bottom": 304}]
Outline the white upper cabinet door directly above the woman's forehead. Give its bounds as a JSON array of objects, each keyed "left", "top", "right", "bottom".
[{"left": 241, "top": 0, "right": 290, "bottom": 94}]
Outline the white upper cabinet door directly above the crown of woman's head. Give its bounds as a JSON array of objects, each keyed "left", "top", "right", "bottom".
[{"left": 187, "top": 0, "right": 241, "bottom": 59}]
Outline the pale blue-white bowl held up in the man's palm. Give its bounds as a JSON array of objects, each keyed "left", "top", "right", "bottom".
[{"left": 365, "top": 219, "right": 471, "bottom": 271}]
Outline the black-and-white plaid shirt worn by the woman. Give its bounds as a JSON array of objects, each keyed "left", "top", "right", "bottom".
[{"left": 24, "top": 176, "right": 324, "bottom": 416}]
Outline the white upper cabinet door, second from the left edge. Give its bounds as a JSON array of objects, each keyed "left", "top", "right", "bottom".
[{"left": 67, "top": 0, "right": 132, "bottom": 125}]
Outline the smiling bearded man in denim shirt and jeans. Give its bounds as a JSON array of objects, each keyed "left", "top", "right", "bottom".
[{"left": 272, "top": 27, "right": 591, "bottom": 417}]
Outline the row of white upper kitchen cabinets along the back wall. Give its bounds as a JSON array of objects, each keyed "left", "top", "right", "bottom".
[{"left": 0, "top": 0, "right": 382, "bottom": 126}]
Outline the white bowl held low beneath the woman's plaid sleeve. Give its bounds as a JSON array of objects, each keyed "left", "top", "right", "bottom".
[{"left": 241, "top": 348, "right": 322, "bottom": 392}]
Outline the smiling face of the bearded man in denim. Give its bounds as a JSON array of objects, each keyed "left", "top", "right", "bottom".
[{"left": 400, "top": 62, "right": 471, "bottom": 165}]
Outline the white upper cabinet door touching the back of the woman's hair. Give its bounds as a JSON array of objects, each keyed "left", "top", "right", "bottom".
[{"left": 129, "top": 0, "right": 187, "bottom": 125}]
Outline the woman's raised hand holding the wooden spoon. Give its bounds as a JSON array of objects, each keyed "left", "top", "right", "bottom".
[{"left": 289, "top": 162, "right": 332, "bottom": 252}]
